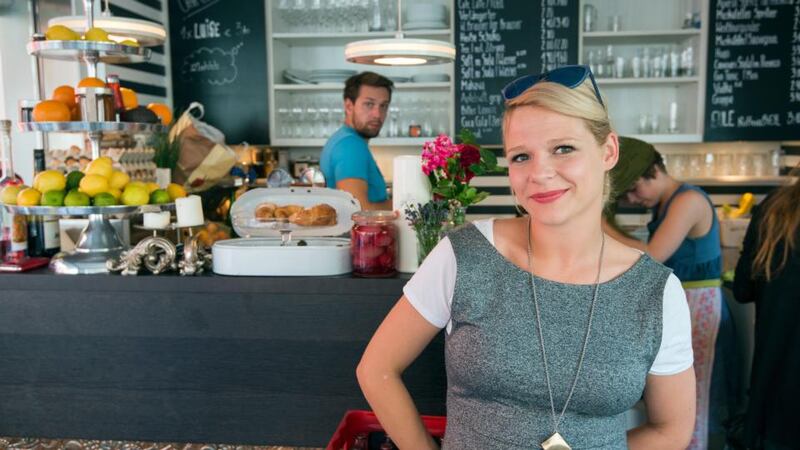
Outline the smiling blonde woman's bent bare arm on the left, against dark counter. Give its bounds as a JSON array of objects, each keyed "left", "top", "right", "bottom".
[{"left": 356, "top": 296, "right": 440, "bottom": 450}]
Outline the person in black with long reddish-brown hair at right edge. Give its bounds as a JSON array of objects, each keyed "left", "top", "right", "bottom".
[{"left": 734, "top": 171, "right": 800, "bottom": 450}]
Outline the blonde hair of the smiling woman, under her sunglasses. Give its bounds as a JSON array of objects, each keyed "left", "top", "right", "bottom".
[{"left": 503, "top": 77, "right": 613, "bottom": 205}]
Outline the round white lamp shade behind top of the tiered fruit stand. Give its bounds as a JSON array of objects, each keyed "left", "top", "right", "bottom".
[{"left": 47, "top": 16, "right": 167, "bottom": 47}]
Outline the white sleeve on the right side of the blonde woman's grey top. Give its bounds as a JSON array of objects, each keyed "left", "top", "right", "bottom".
[{"left": 650, "top": 274, "right": 694, "bottom": 375}]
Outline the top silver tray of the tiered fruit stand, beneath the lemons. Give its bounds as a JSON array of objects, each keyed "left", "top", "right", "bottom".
[{"left": 27, "top": 40, "right": 151, "bottom": 64}]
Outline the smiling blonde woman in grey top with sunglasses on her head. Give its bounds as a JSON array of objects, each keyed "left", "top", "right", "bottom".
[{"left": 357, "top": 66, "right": 694, "bottom": 450}]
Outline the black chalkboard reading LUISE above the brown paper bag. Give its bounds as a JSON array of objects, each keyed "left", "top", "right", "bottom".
[{"left": 169, "top": 0, "right": 269, "bottom": 144}]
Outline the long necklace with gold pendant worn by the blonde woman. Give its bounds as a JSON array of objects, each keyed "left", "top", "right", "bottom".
[{"left": 528, "top": 217, "right": 606, "bottom": 450}]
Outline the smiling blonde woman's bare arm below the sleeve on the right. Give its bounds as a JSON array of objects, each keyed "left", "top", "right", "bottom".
[{"left": 628, "top": 367, "right": 696, "bottom": 450}]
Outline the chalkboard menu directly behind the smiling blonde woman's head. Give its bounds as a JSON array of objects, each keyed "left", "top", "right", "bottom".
[{"left": 455, "top": 0, "right": 579, "bottom": 145}]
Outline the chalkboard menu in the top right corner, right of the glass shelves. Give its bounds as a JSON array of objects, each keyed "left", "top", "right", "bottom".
[{"left": 705, "top": 0, "right": 800, "bottom": 141}]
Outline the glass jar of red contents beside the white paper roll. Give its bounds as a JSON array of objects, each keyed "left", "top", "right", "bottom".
[{"left": 350, "top": 211, "right": 397, "bottom": 277}]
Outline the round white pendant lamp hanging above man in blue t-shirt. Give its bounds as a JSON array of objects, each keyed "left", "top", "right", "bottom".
[{"left": 344, "top": 0, "right": 456, "bottom": 66}]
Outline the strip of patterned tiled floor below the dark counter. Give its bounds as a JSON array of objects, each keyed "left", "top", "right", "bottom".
[{"left": 0, "top": 437, "right": 323, "bottom": 450}]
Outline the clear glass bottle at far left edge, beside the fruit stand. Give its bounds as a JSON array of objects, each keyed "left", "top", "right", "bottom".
[{"left": 0, "top": 120, "right": 28, "bottom": 263}]
